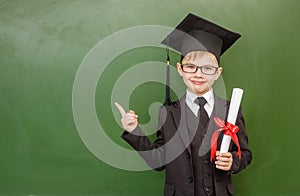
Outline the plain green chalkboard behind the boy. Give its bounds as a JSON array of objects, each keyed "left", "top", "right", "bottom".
[{"left": 0, "top": 0, "right": 300, "bottom": 195}]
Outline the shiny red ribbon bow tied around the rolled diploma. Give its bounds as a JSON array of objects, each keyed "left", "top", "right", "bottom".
[{"left": 210, "top": 117, "right": 242, "bottom": 161}]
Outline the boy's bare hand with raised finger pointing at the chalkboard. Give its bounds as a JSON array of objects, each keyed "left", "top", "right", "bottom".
[{"left": 115, "top": 102, "right": 138, "bottom": 132}]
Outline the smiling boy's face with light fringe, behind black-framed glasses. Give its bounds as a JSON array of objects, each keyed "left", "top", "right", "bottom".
[{"left": 177, "top": 51, "right": 222, "bottom": 96}]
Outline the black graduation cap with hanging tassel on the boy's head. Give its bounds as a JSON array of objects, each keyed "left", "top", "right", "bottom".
[{"left": 161, "top": 13, "right": 241, "bottom": 104}]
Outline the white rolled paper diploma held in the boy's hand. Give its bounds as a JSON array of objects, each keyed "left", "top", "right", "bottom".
[{"left": 220, "top": 88, "right": 243, "bottom": 153}]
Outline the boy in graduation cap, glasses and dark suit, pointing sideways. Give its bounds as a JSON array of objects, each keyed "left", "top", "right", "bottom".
[{"left": 116, "top": 14, "right": 252, "bottom": 196}]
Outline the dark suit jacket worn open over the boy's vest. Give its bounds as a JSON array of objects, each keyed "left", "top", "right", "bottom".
[{"left": 121, "top": 95, "right": 252, "bottom": 195}]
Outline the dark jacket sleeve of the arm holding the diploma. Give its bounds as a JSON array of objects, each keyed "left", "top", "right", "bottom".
[{"left": 230, "top": 108, "right": 252, "bottom": 174}]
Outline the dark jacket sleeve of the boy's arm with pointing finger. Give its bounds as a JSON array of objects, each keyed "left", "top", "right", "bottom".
[{"left": 121, "top": 107, "right": 166, "bottom": 171}]
